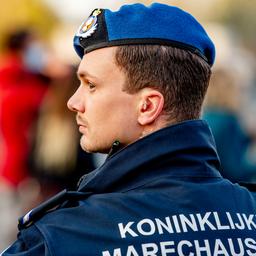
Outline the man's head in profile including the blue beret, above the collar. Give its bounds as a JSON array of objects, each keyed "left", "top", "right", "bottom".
[{"left": 68, "top": 4, "right": 214, "bottom": 152}]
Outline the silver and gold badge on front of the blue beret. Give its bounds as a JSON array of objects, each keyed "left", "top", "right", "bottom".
[{"left": 76, "top": 9, "right": 101, "bottom": 38}]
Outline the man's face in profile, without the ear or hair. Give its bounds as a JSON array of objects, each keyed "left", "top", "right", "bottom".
[{"left": 68, "top": 47, "right": 141, "bottom": 153}]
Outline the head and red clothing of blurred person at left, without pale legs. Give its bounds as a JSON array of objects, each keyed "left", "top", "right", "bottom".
[{"left": 0, "top": 30, "right": 47, "bottom": 187}]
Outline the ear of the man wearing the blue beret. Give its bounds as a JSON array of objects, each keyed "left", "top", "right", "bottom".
[{"left": 138, "top": 88, "right": 164, "bottom": 125}]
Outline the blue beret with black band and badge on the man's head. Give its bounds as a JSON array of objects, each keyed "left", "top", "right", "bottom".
[{"left": 74, "top": 3, "right": 215, "bottom": 66}]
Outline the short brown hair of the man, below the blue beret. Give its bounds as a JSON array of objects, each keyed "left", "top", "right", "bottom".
[{"left": 115, "top": 45, "right": 211, "bottom": 121}]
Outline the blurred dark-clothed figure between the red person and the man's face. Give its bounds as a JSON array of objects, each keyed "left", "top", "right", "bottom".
[{"left": 30, "top": 67, "right": 95, "bottom": 200}]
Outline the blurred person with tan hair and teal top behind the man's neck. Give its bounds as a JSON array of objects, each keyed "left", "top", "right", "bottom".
[{"left": 204, "top": 67, "right": 256, "bottom": 182}]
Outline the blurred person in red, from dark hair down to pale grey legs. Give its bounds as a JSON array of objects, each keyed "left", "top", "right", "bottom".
[{"left": 0, "top": 29, "right": 48, "bottom": 248}]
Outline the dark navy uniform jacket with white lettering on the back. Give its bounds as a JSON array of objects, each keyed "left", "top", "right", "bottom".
[{"left": 3, "top": 120, "right": 256, "bottom": 256}]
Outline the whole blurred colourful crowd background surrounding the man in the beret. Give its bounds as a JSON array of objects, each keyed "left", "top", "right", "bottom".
[{"left": 0, "top": 0, "right": 256, "bottom": 251}]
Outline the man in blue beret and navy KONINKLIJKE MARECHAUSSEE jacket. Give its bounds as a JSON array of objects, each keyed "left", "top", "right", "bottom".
[{"left": 3, "top": 3, "right": 256, "bottom": 256}]
